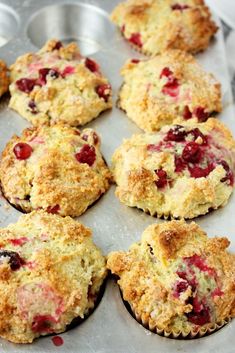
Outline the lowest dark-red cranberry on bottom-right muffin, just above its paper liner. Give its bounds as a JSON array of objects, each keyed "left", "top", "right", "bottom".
[{"left": 186, "top": 298, "right": 210, "bottom": 326}]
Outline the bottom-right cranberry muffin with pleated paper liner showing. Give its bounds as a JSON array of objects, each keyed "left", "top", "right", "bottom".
[{"left": 107, "top": 220, "right": 235, "bottom": 338}]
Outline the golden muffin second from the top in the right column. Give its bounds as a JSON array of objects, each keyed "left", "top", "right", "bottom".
[{"left": 118, "top": 50, "right": 222, "bottom": 132}]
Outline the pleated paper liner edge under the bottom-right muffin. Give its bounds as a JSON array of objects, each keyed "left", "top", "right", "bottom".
[{"left": 124, "top": 301, "right": 232, "bottom": 339}]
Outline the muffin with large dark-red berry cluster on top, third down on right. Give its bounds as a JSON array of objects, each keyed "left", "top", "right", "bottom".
[{"left": 112, "top": 118, "right": 235, "bottom": 218}]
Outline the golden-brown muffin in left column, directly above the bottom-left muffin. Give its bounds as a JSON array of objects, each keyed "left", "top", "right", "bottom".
[{"left": 0, "top": 124, "right": 111, "bottom": 217}]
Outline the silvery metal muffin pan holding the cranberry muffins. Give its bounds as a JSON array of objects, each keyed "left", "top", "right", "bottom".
[{"left": 0, "top": 0, "right": 235, "bottom": 353}]
